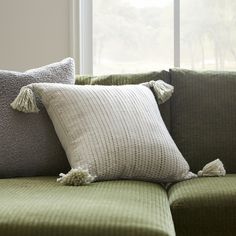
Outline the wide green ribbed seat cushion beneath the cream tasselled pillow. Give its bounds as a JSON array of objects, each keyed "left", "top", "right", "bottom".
[{"left": 0, "top": 177, "right": 175, "bottom": 236}]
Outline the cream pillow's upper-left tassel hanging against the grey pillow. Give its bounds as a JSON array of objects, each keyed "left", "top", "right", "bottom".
[{"left": 11, "top": 85, "right": 39, "bottom": 113}]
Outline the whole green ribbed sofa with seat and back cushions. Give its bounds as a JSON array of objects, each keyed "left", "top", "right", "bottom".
[{"left": 0, "top": 69, "right": 236, "bottom": 236}]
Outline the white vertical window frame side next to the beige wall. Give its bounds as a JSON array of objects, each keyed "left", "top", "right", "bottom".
[{"left": 79, "top": 0, "right": 93, "bottom": 75}]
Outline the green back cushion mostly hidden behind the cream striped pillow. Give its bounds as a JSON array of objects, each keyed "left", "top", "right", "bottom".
[{"left": 75, "top": 70, "right": 170, "bottom": 131}]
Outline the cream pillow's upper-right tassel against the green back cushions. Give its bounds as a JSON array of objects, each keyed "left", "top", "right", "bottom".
[{"left": 142, "top": 80, "right": 174, "bottom": 104}]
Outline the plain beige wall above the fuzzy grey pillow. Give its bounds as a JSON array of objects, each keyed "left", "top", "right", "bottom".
[{"left": 0, "top": 0, "right": 70, "bottom": 71}]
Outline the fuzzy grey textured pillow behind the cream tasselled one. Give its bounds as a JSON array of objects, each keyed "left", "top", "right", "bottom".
[{"left": 0, "top": 58, "right": 74, "bottom": 178}]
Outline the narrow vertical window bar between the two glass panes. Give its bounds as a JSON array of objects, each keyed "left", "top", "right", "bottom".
[{"left": 174, "top": 0, "right": 180, "bottom": 67}]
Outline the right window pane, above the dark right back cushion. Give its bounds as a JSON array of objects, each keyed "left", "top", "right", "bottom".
[{"left": 180, "top": 0, "right": 236, "bottom": 70}]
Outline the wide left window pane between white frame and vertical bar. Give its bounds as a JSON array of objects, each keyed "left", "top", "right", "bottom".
[{"left": 93, "top": 0, "right": 173, "bottom": 74}]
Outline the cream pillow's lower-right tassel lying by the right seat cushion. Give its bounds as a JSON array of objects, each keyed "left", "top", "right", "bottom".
[{"left": 197, "top": 159, "right": 226, "bottom": 177}]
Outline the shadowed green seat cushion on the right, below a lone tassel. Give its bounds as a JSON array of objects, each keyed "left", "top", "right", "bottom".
[{"left": 168, "top": 174, "right": 236, "bottom": 236}]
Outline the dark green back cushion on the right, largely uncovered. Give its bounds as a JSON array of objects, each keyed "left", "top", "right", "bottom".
[{"left": 170, "top": 69, "right": 236, "bottom": 173}]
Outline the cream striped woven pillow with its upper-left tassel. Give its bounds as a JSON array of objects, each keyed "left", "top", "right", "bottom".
[{"left": 12, "top": 83, "right": 194, "bottom": 182}]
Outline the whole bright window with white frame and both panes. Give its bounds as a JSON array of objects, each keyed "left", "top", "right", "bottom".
[{"left": 80, "top": 0, "right": 236, "bottom": 74}]
